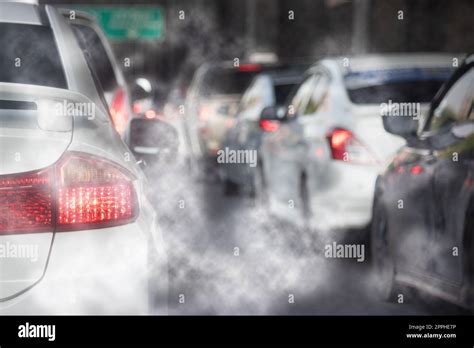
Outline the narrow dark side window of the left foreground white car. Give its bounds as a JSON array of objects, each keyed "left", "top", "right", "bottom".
[{"left": 72, "top": 24, "right": 118, "bottom": 92}]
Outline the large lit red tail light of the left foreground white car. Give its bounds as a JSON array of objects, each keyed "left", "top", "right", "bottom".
[{"left": 0, "top": 152, "right": 138, "bottom": 234}]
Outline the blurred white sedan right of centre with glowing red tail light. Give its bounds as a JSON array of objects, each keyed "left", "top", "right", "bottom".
[{"left": 257, "top": 54, "right": 455, "bottom": 230}]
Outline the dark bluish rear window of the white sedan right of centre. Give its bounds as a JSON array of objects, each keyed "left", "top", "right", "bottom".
[{"left": 344, "top": 68, "right": 452, "bottom": 104}]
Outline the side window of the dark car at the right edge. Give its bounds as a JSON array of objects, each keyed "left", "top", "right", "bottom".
[{"left": 429, "top": 68, "right": 474, "bottom": 131}]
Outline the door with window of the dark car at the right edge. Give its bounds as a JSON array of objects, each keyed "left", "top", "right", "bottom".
[{"left": 428, "top": 64, "right": 474, "bottom": 285}]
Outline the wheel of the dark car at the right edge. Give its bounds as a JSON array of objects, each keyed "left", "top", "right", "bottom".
[{"left": 371, "top": 202, "right": 395, "bottom": 301}]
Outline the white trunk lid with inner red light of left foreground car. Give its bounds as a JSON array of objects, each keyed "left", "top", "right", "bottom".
[{"left": 0, "top": 84, "right": 77, "bottom": 301}]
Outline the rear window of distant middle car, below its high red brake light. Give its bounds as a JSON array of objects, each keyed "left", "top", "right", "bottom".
[{"left": 199, "top": 69, "right": 257, "bottom": 96}]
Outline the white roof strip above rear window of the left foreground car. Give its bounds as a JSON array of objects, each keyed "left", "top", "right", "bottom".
[{"left": 0, "top": 2, "right": 48, "bottom": 25}]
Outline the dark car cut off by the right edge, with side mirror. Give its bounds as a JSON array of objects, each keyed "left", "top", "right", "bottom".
[{"left": 371, "top": 55, "right": 474, "bottom": 309}]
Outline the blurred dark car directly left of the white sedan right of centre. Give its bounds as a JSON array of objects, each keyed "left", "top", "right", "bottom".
[{"left": 218, "top": 67, "right": 304, "bottom": 195}]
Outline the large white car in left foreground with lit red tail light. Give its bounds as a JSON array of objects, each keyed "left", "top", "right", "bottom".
[{"left": 0, "top": 3, "right": 168, "bottom": 314}]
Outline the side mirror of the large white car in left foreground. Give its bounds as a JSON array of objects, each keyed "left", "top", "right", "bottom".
[{"left": 128, "top": 118, "right": 179, "bottom": 165}]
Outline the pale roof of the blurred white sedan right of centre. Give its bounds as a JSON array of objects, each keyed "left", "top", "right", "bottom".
[{"left": 313, "top": 53, "right": 465, "bottom": 75}]
